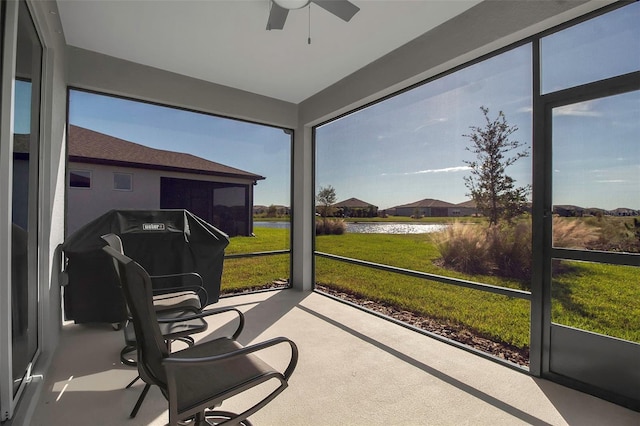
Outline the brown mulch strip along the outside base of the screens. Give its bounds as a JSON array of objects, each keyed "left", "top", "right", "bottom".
[{"left": 221, "top": 280, "right": 529, "bottom": 366}]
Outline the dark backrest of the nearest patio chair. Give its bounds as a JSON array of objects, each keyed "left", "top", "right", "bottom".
[{"left": 102, "top": 245, "right": 169, "bottom": 390}]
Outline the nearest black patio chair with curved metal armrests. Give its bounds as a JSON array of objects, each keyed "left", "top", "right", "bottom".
[{"left": 103, "top": 241, "right": 298, "bottom": 426}]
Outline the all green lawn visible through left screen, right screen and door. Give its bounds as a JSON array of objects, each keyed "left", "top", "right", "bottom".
[{"left": 223, "top": 228, "right": 640, "bottom": 348}]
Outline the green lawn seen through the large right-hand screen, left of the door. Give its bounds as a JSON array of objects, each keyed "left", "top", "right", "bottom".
[{"left": 316, "top": 234, "right": 530, "bottom": 348}]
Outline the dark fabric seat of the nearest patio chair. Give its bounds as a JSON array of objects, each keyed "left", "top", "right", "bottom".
[{"left": 170, "top": 337, "right": 281, "bottom": 412}]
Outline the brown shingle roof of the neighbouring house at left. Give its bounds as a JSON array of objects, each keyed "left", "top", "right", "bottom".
[{"left": 67, "top": 126, "right": 264, "bottom": 181}]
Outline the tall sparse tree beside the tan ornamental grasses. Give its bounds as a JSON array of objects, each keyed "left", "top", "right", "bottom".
[{"left": 463, "top": 106, "right": 531, "bottom": 225}]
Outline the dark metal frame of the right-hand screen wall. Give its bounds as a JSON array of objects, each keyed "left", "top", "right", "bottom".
[{"left": 310, "top": 2, "right": 640, "bottom": 377}]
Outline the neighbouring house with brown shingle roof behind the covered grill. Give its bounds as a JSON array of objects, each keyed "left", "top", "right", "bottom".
[{"left": 67, "top": 126, "right": 264, "bottom": 236}]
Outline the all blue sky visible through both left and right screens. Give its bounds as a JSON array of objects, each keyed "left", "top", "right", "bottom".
[{"left": 57, "top": 3, "right": 640, "bottom": 209}]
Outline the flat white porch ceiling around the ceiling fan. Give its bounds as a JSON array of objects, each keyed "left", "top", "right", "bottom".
[{"left": 57, "top": 0, "right": 480, "bottom": 103}]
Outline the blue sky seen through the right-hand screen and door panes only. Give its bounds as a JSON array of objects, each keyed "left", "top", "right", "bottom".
[{"left": 316, "top": 4, "right": 640, "bottom": 209}]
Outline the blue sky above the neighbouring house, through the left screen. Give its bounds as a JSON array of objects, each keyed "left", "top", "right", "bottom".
[{"left": 69, "top": 90, "right": 291, "bottom": 206}]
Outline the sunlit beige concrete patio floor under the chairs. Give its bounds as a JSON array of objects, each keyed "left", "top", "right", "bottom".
[{"left": 31, "top": 290, "right": 640, "bottom": 426}]
